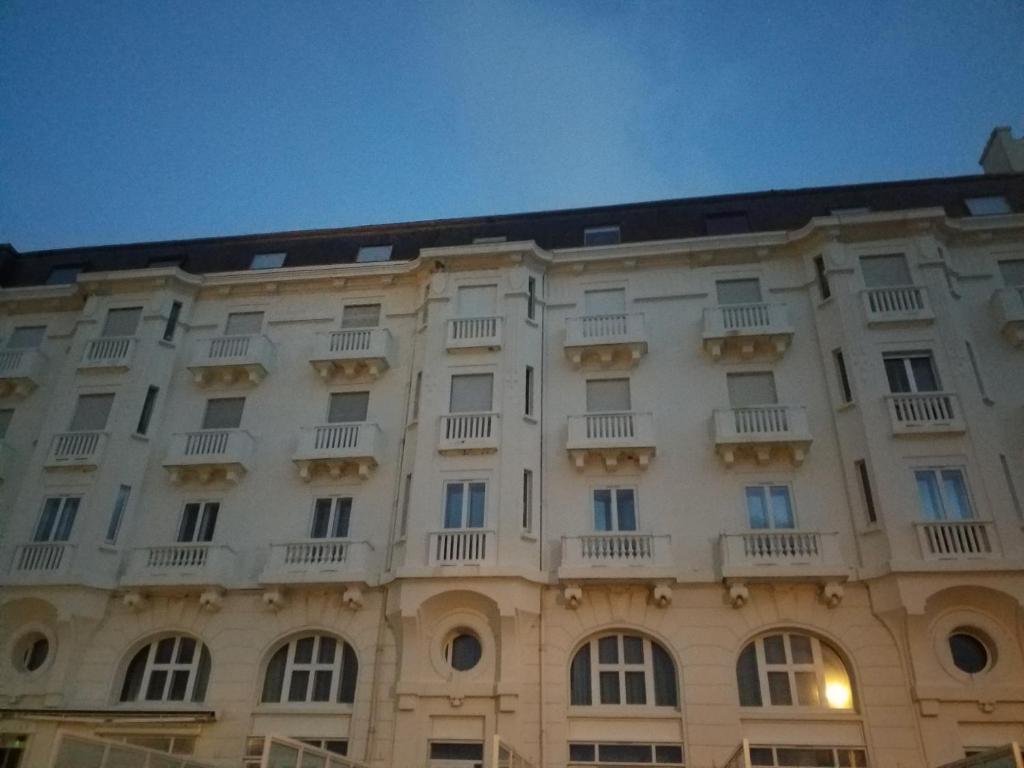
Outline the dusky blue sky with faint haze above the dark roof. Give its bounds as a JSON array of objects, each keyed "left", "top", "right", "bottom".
[{"left": 0, "top": 0, "right": 1024, "bottom": 251}]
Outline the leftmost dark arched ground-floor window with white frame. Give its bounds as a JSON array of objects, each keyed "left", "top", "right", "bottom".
[{"left": 120, "top": 635, "right": 210, "bottom": 701}]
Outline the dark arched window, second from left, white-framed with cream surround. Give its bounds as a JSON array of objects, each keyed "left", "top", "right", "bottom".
[{"left": 260, "top": 635, "right": 359, "bottom": 703}]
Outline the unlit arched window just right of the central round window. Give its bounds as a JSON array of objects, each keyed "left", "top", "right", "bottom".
[{"left": 569, "top": 634, "right": 679, "bottom": 707}]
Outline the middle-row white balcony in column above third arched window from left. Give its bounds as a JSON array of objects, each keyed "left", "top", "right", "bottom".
[{"left": 565, "top": 411, "right": 656, "bottom": 470}]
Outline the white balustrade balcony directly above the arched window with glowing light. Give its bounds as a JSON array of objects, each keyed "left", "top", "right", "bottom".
[{"left": 719, "top": 530, "right": 849, "bottom": 581}]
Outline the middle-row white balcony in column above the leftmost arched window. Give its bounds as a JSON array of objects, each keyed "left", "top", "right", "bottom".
[{"left": 164, "top": 429, "right": 254, "bottom": 482}]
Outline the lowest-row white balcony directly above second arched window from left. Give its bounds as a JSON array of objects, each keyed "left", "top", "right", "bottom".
[{"left": 259, "top": 539, "right": 373, "bottom": 584}]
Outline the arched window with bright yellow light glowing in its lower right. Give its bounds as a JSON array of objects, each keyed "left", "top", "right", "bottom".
[{"left": 736, "top": 632, "right": 853, "bottom": 710}]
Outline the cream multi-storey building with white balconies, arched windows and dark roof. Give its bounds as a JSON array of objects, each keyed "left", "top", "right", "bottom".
[{"left": 0, "top": 169, "right": 1024, "bottom": 768}]
